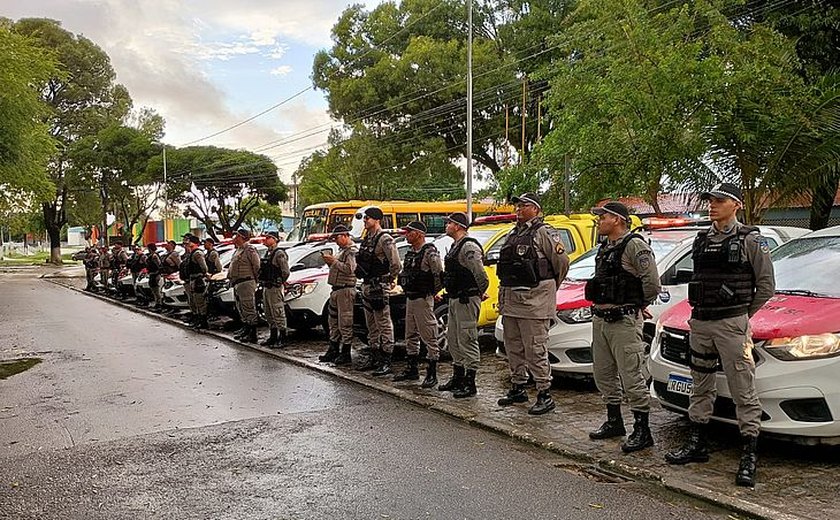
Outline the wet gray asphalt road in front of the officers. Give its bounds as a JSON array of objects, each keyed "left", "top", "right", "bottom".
[{"left": 0, "top": 275, "right": 733, "bottom": 520}]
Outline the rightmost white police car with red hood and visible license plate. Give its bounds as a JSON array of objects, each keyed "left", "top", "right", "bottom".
[{"left": 649, "top": 226, "right": 840, "bottom": 444}]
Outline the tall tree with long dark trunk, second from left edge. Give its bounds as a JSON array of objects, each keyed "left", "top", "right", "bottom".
[{"left": 13, "top": 18, "right": 131, "bottom": 263}]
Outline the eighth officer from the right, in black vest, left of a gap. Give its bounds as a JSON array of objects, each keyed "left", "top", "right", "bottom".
[{"left": 259, "top": 231, "right": 289, "bottom": 348}]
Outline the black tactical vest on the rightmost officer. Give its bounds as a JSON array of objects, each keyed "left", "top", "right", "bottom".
[{"left": 688, "top": 226, "right": 758, "bottom": 320}]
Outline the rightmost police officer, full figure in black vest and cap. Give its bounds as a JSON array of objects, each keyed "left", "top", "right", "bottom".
[{"left": 665, "top": 183, "right": 776, "bottom": 487}]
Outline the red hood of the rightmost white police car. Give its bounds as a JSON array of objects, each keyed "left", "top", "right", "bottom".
[{"left": 659, "top": 294, "right": 840, "bottom": 339}]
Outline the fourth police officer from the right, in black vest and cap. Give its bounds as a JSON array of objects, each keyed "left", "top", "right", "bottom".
[{"left": 438, "top": 212, "right": 490, "bottom": 398}]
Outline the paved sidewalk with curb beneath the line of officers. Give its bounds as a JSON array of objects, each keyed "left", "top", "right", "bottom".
[{"left": 49, "top": 279, "right": 840, "bottom": 520}]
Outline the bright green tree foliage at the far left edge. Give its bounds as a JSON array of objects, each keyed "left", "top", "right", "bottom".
[{"left": 0, "top": 25, "right": 61, "bottom": 200}]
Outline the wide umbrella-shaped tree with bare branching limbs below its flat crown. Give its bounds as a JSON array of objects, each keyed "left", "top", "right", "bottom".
[{"left": 159, "top": 146, "right": 286, "bottom": 238}]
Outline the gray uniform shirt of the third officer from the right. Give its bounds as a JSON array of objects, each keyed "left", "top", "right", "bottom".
[{"left": 499, "top": 217, "right": 569, "bottom": 320}]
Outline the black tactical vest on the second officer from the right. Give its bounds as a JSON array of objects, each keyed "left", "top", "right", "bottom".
[{"left": 584, "top": 233, "right": 646, "bottom": 307}]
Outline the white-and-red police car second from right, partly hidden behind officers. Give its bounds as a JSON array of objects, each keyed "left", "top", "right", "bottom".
[{"left": 494, "top": 221, "right": 809, "bottom": 377}]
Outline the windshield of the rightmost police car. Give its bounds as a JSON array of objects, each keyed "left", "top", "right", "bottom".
[{"left": 770, "top": 237, "right": 840, "bottom": 298}]
